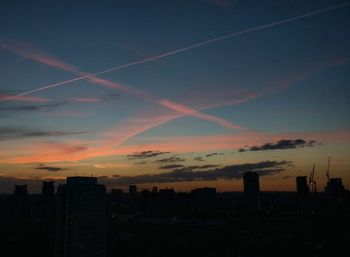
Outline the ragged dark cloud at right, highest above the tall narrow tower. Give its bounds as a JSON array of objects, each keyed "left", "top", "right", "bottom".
[{"left": 238, "top": 139, "right": 320, "bottom": 152}]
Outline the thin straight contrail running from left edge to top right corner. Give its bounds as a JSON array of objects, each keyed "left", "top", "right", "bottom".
[{"left": 0, "top": 2, "right": 350, "bottom": 103}]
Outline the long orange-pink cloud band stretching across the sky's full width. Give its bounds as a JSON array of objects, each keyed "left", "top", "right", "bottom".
[{"left": 1, "top": 126, "right": 350, "bottom": 163}]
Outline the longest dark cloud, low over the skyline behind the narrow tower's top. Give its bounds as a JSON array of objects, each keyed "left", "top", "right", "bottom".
[{"left": 106, "top": 161, "right": 291, "bottom": 186}]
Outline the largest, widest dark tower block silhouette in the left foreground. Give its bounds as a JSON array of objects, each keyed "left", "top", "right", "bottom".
[{"left": 55, "top": 177, "right": 106, "bottom": 257}]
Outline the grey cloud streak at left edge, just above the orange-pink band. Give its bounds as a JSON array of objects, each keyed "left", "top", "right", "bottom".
[{"left": 0, "top": 127, "right": 86, "bottom": 141}]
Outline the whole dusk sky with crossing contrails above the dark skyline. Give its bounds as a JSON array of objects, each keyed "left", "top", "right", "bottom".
[{"left": 0, "top": 0, "right": 350, "bottom": 193}]
